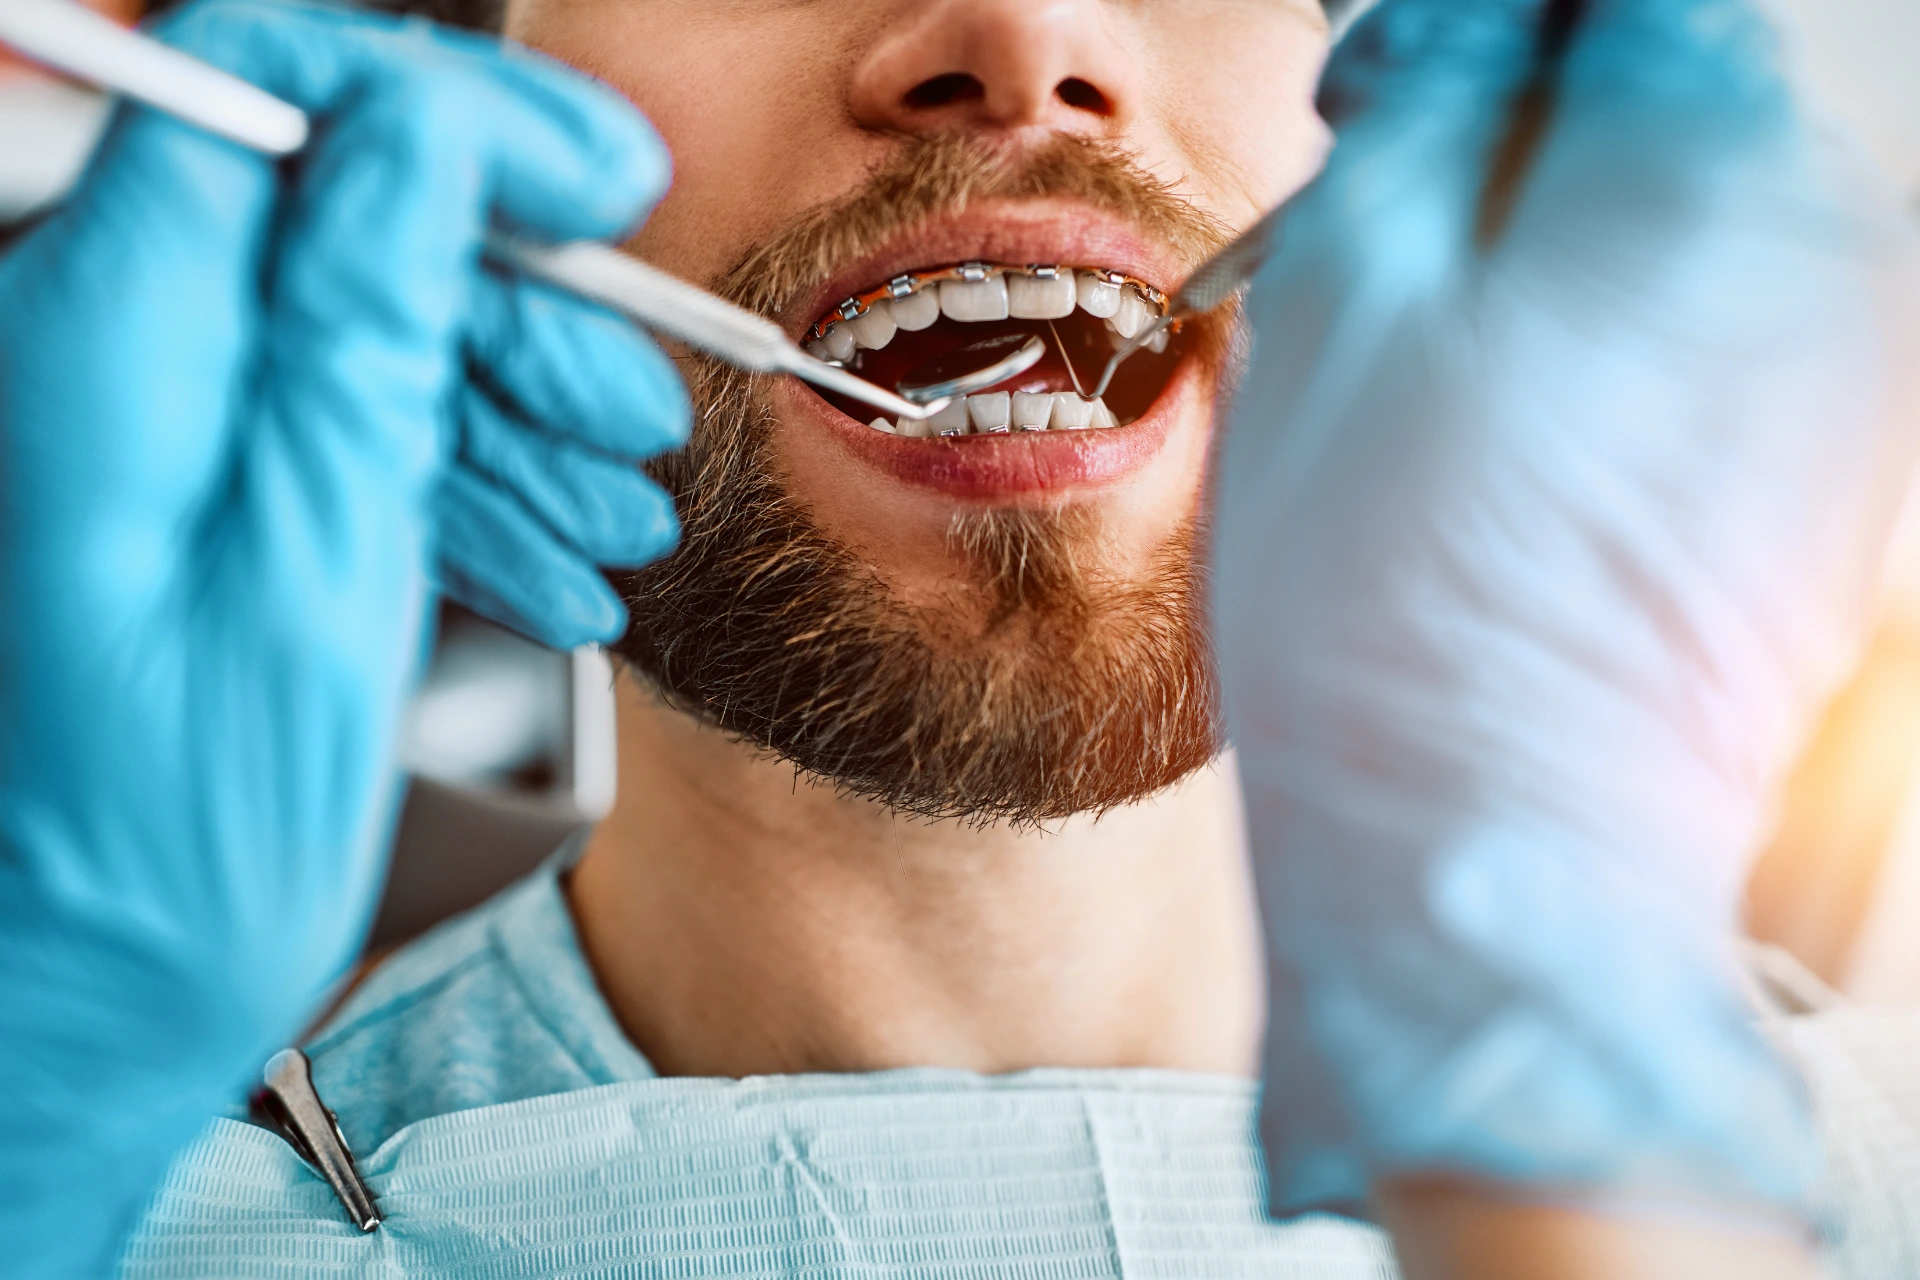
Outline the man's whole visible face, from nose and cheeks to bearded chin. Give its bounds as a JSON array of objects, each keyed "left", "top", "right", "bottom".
[{"left": 507, "top": 0, "right": 1327, "bottom": 819}]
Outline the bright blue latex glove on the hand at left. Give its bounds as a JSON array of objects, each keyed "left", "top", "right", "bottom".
[{"left": 0, "top": 0, "right": 687, "bottom": 1276}]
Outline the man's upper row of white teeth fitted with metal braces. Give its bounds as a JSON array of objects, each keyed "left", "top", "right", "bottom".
[{"left": 806, "top": 263, "right": 1165, "bottom": 365}]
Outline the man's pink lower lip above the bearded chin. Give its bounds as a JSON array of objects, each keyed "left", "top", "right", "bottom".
[{"left": 774, "top": 359, "right": 1200, "bottom": 501}]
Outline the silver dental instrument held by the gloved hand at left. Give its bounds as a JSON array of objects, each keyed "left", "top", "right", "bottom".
[{"left": 0, "top": 0, "right": 947, "bottom": 420}]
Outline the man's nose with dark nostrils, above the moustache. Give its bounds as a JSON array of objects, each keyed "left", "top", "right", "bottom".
[{"left": 851, "top": 0, "right": 1139, "bottom": 136}]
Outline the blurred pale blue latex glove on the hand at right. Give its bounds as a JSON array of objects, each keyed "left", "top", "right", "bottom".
[{"left": 1213, "top": 0, "right": 1920, "bottom": 1215}]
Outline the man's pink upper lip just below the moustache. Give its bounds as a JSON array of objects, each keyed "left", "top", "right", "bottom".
[{"left": 781, "top": 200, "right": 1190, "bottom": 338}]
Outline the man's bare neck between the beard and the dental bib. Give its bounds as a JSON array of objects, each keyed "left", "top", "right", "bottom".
[{"left": 568, "top": 677, "right": 1261, "bottom": 1077}]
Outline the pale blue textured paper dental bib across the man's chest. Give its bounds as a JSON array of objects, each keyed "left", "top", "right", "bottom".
[{"left": 123, "top": 1071, "right": 1396, "bottom": 1280}]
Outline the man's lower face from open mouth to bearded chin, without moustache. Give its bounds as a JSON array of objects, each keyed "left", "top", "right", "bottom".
[{"left": 620, "top": 205, "right": 1223, "bottom": 823}]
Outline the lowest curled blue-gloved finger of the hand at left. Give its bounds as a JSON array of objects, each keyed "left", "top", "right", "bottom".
[{"left": 434, "top": 468, "right": 626, "bottom": 649}]
